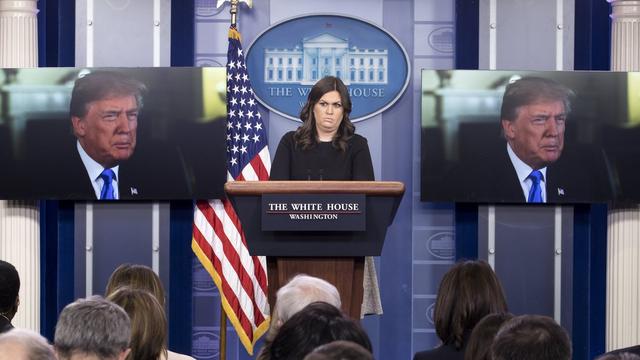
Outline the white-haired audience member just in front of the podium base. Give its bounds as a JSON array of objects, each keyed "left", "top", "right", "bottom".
[{"left": 257, "top": 274, "right": 342, "bottom": 360}]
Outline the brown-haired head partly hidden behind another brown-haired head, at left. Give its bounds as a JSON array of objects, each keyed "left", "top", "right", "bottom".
[{"left": 105, "top": 264, "right": 165, "bottom": 308}]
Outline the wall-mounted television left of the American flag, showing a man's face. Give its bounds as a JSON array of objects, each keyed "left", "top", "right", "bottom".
[{"left": 0, "top": 67, "right": 227, "bottom": 201}]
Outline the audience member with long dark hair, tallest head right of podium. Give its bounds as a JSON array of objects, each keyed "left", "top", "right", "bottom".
[{"left": 413, "top": 261, "right": 508, "bottom": 360}]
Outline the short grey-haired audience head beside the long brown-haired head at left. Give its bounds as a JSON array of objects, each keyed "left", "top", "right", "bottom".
[{"left": 54, "top": 296, "right": 131, "bottom": 360}]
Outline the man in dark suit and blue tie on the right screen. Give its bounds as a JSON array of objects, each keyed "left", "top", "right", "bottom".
[{"left": 455, "top": 77, "right": 611, "bottom": 203}]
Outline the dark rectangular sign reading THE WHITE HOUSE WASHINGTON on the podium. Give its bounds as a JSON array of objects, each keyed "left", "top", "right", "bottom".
[{"left": 262, "top": 194, "right": 366, "bottom": 231}]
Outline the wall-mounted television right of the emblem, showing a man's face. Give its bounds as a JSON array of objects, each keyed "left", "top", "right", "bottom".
[{"left": 421, "top": 70, "right": 640, "bottom": 204}]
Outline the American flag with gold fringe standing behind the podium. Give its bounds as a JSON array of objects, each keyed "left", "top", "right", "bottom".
[{"left": 191, "top": 26, "right": 271, "bottom": 354}]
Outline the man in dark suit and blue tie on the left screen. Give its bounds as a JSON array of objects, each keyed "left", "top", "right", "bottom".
[{"left": 41, "top": 71, "right": 190, "bottom": 200}]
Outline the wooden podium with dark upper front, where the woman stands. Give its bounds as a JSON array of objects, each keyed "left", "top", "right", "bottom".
[{"left": 225, "top": 181, "right": 404, "bottom": 319}]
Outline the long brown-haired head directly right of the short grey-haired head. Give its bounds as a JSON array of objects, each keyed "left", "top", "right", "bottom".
[{"left": 107, "top": 286, "right": 167, "bottom": 360}]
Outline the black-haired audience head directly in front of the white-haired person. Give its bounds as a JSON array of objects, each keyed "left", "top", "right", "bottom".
[{"left": 269, "top": 302, "right": 371, "bottom": 360}]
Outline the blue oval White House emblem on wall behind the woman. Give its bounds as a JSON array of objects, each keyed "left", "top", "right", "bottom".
[{"left": 246, "top": 15, "right": 410, "bottom": 122}]
